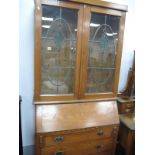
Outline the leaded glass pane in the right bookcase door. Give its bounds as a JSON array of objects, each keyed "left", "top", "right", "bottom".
[{"left": 86, "top": 13, "right": 119, "bottom": 93}]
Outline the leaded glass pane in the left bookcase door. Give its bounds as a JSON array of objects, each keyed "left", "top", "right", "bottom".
[{"left": 41, "top": 5, "right": 78, "bottom": 95}]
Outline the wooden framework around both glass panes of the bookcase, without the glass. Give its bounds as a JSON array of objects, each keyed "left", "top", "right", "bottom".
[{"left": 34, "top": 0, "right": 127, "bottom": 102}]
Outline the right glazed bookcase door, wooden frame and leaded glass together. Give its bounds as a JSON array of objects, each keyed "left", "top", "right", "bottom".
[{"left": 80, "top": 6, "right": 123, "bottom": 98}]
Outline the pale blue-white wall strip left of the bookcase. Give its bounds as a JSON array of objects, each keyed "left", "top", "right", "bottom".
[{"left": 19, "top": 0, "right": 35, "bottom": 146}]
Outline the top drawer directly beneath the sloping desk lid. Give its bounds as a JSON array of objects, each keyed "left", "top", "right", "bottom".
[{"left": 40, "top": 125, "right": 118, "bottom": 147}]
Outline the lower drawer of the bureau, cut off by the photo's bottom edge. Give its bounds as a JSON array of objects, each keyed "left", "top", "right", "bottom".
[{"left": 41, "top": 139, "right": 113, "bottom": 155}]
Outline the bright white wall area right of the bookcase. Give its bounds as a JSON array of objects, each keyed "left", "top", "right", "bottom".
[{"left": 105, "top": 0, "right": 135, "bottom": 92}]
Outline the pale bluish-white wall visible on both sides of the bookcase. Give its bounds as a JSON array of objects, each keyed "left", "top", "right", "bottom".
[{"left": 19, "top": 0, "right": 134, "bottom": 146}]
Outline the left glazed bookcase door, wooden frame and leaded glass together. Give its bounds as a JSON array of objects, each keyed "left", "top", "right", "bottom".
[{"left": 36, "top": 0, "right": 83, "bottom": 101}]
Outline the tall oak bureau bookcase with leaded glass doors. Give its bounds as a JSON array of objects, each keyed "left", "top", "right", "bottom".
[{"left": 34, "top": 0, "right": 127, "bottom": 155}]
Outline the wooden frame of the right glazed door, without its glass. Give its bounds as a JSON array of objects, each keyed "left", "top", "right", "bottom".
[{"left": 79, "top": 6, "right": 125, "bottom": 99}]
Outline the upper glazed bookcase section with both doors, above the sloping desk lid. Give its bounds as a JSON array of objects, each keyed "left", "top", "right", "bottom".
[{"left": 35, "top": 0, "right": 125, "bottom": 101}]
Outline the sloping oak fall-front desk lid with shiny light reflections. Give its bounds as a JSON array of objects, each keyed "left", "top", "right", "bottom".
[{"left": 36, "top": 101, "right": 119, "bottom": 133}]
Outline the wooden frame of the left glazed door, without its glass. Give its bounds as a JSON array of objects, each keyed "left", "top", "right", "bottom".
[{"left": 34, "top": 0, "right": 83, "bottom": 101}]
